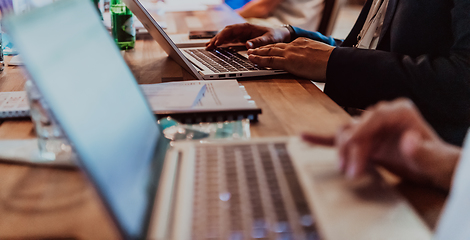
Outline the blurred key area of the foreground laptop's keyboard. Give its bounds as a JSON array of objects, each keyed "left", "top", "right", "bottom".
[{"left": 192, "top": 143, "right": 320, "bottom": 240}]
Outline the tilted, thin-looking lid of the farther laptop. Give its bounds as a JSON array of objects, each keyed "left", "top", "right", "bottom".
[{"left": 123, "top": 0, "right": 203, "bottom": 80}]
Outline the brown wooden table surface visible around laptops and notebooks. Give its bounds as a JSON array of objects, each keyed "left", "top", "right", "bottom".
[{"left": 0, "top": 3, "right": 446, "bottom": 239}]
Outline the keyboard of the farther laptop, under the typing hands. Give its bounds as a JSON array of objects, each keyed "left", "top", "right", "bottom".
[{"left": 184, "top": 48, "right": 264, "bottom": 73}]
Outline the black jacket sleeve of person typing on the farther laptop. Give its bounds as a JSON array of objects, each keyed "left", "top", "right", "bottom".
[{"left": 325, "top": 0, "right": 470, "bottom": 145}]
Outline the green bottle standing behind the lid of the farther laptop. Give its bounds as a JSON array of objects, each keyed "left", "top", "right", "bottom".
[{"left": 109, "top": 0, "right": 135, "bottom": 50}]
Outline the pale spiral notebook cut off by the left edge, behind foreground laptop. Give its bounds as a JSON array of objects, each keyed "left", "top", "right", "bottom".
[{"left": 0, "top": 91, "right": 29, "bottom": 119}]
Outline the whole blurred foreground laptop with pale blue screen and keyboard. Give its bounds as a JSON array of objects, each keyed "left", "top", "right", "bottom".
[{"left": 3, "top": 0, "right": 430, "bottom": 240}]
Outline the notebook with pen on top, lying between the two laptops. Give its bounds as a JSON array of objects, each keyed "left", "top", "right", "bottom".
[{"left": 140, "top": 80, "right": 261, "bottom": 123}]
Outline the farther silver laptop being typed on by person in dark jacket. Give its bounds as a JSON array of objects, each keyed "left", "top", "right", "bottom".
[{"left": 123, "top": 0, "right": 287, "bottom": 80}]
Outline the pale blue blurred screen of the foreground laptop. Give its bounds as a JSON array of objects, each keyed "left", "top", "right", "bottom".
[{"left": 4, "top": 0, "right": 161, "bottom": 238}]
